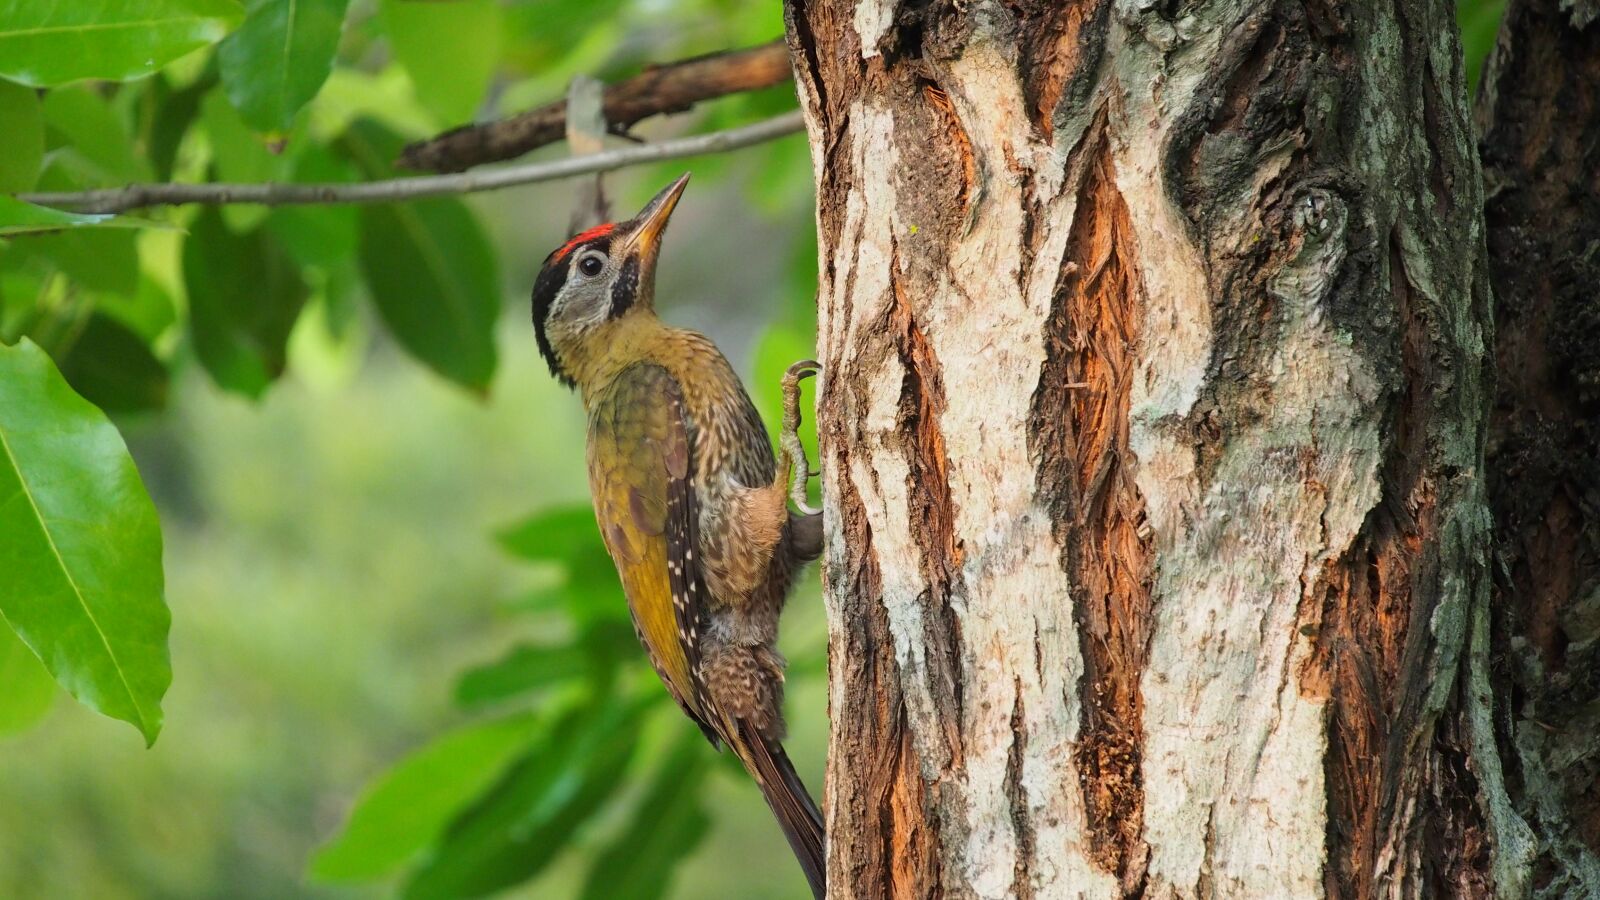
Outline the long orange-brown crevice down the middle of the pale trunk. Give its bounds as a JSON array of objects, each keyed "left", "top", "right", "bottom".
[{"left": 1030, "top": 120, "right": 1152, "bottom": 889}]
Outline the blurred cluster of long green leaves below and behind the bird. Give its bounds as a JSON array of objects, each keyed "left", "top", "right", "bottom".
[{"left": 310, "top": 506, "right": 761, "bottom": 898}]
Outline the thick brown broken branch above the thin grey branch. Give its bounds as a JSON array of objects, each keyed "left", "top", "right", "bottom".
[{"left": 400, "top": 40, "right": 794, "bottom": 171}]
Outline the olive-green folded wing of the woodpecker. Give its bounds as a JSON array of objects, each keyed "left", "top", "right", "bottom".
[{"left": 589, "top": 364, "right": 717, "bottom": 743}]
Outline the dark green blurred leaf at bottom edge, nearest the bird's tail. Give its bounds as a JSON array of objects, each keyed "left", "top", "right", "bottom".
[{"left": 582, "top": 725, "right": 715, "bottom": 900}]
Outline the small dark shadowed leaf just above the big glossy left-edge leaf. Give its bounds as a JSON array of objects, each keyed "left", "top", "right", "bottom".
[{"left": 56, "top": 312, "right": 166, "bottom": 413}]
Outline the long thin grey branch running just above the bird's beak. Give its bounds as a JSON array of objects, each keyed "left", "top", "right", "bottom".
[{"left": 16, "top": 110, "right": 805, "bottom": 213}]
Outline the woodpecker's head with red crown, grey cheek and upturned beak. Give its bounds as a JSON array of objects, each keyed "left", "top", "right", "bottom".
[{"left": 533, "top": 175, "right": 690, "bottom": 386}]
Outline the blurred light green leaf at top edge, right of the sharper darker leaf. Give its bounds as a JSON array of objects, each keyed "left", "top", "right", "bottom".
[{"left": 378, "top": 0, "right": 502, "bottom": 125}]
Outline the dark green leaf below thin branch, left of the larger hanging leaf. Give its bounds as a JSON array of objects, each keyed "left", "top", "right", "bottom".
[{"left": 184, "top": 207, "right": 310, "bottom": 397}]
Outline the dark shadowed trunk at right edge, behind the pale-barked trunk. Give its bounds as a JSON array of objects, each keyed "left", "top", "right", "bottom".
[{"left": 1478, "top": 0, "right": 1600, "bottom": 898}]
